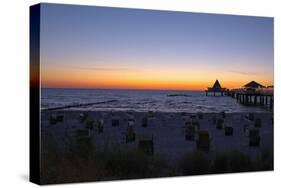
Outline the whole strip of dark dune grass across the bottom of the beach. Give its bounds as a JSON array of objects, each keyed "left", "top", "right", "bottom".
[{"left": 41, "top": 133, "right": 273, "bottom": 184}]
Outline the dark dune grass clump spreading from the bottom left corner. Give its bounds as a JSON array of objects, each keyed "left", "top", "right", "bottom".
[{"left": 41, "top": 134, "right": 170, "bottom": 184}]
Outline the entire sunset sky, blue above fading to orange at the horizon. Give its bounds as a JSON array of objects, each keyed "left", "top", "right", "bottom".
[{"left": 40, "top": 4, "right": 274, "bottom": 90}]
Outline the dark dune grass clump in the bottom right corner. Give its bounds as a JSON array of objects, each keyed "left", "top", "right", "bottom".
[{"left": 178, "top": 149, "right": 273, "bottom": 175}]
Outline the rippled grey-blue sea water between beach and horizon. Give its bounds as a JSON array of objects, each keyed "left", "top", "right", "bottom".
[{"left": 41, "top": 88, "right": 266, "bottom": 113}]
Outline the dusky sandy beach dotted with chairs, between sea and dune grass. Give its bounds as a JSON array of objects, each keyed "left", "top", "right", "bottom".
[{"left": 41, "top": 110, "right": 273, "bottom": 163}]
